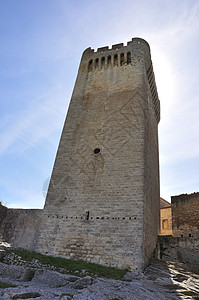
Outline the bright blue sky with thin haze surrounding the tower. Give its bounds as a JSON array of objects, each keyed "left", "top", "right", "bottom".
[{"left": 0, "top": 0, "right": 199, "bottom": 208}]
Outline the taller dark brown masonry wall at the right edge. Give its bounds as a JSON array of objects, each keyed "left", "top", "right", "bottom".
[{"left": 171, "top": 193, "right": 199, "bottom": 238}]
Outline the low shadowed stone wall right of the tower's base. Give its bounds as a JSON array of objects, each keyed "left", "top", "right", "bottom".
[{"left": 156, "top": 236, "right": 199, "bottom": 265}]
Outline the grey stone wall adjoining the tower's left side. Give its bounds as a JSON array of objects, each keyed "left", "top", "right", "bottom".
[{"left": 0, "top": 205, "right": 42, "bottom": 250}]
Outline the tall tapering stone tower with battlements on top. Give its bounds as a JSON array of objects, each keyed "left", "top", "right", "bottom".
[{"left": 35, "top": 38, "right": 160, "bottom": 270}]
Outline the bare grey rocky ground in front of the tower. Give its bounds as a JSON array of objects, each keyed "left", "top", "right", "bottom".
[{"left": 0, "top": 243, "right": 199, "bottom": 300}]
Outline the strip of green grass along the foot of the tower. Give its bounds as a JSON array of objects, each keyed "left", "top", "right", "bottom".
[{"left": 12, "top": 250, "right": 128, "bottom": 279}]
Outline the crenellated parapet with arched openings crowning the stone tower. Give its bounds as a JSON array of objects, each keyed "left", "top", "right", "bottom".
[{"left": 82, "top": 38, "right": 160, "bottom": 123}]
